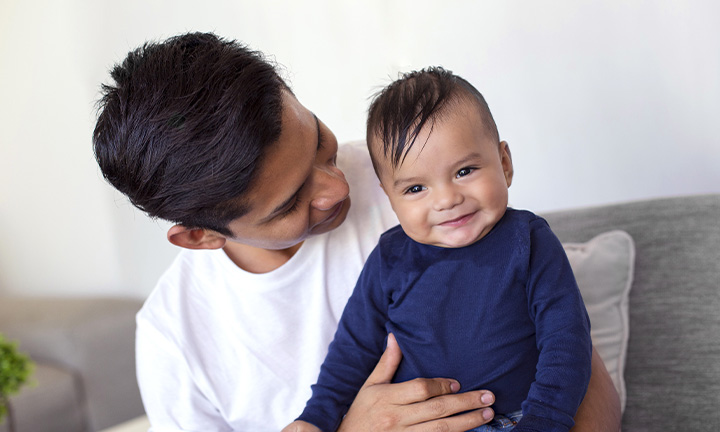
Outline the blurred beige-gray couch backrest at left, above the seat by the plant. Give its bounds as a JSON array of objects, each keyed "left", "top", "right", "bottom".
[{"left": 0, "top": 297, "right": 144, "bottom": 430}]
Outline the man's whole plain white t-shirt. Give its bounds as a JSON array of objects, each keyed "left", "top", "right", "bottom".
[{"left": 136, "top": 143, "right": 397, "bottom": 432}]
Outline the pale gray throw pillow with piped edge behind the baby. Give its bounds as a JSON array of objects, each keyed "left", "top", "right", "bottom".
[{"left": 563, "top": 231, "right": 635, "bottom": 411}]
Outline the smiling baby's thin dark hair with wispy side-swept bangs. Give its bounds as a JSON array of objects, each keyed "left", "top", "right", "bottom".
[{"left": 367, "top": 66, "right": 500, "bottom": 173}]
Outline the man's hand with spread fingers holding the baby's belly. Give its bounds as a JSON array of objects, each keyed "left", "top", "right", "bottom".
[{"left": 338, "top": 334, "right": 495, "bottom": 432}]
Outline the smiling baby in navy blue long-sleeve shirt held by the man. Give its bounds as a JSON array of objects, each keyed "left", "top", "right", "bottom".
[{"left": 286, "top": 68, "right": 592, "bottom": 432}]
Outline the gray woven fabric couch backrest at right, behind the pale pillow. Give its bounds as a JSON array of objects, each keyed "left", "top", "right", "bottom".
[{"left": 543, "top": 195, "right": 720, "bottom": 432}]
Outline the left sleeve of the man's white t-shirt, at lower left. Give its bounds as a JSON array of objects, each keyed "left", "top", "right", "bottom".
[{"left": 135, "top": 308, "right": 232, "bottom": 432}]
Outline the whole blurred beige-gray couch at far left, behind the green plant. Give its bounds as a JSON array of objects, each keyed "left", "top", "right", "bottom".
[{"left": 0, "top": 297, "right": 144, "bottom": 432}]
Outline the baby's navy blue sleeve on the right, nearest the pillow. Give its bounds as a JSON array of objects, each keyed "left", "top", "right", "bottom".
[{"left": 515, "top": 219, "right": 592, "bottom": 432}]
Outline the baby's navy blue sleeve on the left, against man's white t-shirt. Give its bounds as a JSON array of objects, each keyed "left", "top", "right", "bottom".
[{"left": 298, "top": 247, "right": 388, "bottom": 432}]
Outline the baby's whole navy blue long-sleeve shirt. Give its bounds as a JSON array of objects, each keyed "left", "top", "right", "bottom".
[{"left": 299, "top": 209, "right": 592, "bottom": 432}]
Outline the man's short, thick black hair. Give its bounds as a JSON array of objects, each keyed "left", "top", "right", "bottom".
[{"left": 93, "top": 33, "right": 289, "bottom": 235}]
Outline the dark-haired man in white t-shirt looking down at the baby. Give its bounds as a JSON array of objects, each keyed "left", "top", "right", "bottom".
[{"left": 93, "top": 34, "right": 619, "bottom": 431}]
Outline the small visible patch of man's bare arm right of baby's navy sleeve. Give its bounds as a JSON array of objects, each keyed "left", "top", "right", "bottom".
[{"left": 572, "top": 348, "right": 622, "bottom": 432}]
